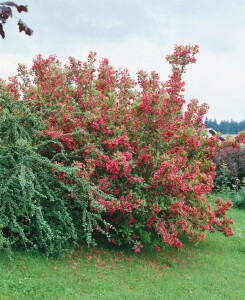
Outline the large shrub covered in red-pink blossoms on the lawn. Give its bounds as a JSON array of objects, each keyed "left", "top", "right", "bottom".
[{"left": 0, "top": 46, "right": 233, "bottom": 252}]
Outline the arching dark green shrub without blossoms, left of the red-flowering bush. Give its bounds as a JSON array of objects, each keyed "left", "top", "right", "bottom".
[{"left": 0, "top": 98, "right": 116, "bottom": 255}]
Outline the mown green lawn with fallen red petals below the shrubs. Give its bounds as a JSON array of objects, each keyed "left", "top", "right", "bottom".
[{"left": 0, "top": 209, "right": 245, "bottom": 300}]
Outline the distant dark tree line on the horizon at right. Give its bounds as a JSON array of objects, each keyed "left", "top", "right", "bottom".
[{"left": 204, "top": 118, "right": 245, "bottom": 134}]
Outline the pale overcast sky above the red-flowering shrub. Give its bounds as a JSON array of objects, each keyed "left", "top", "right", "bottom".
[{"left": 0, "top": 0, "right": 245, "bottom": 121}]
